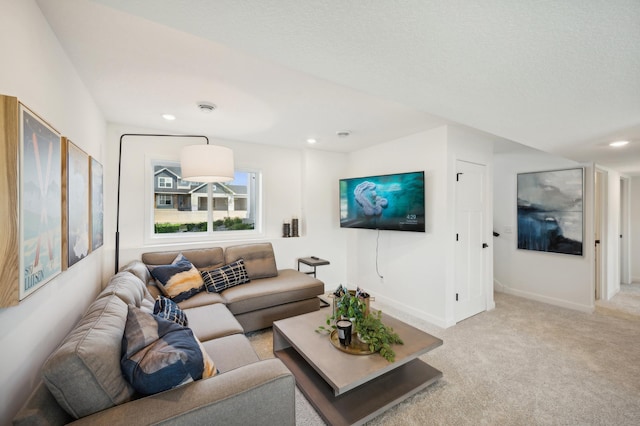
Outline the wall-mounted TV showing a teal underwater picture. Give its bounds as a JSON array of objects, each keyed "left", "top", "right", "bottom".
[{"left": 340, "top": 172, "right": 425, "bottom": 232}]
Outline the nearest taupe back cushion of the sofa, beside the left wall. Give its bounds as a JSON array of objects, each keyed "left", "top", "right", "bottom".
[{"left": 42, "top": 294, "right": 134, "bottom": 418}]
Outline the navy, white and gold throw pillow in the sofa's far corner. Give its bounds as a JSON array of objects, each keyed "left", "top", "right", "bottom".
[{"left": 149, "top": 254, "right": 204, "bottom": 302}]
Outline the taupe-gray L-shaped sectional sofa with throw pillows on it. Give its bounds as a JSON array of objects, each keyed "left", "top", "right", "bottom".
[{"left": 13, "top": 243, "right": 324, "bottom": 425}]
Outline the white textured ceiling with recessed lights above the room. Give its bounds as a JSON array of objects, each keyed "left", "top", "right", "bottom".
[{"left": 38, "top": 0, "right": 640, "bottom": 173}]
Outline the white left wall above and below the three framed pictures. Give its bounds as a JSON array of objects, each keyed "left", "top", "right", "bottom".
[{"left": 0, "top": 0, "right": 105, "bottom": 424}]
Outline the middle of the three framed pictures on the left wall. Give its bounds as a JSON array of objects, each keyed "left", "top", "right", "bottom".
[{"left": 66, "top": 140, "right": 89, "bottom": 266}]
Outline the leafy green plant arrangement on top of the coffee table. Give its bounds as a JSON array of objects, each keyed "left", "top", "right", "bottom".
[{"left": 316, "top": 285, "right": 403, "bottom": 362}]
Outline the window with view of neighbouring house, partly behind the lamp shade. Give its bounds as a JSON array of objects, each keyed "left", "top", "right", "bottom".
[{"left": 153, "top": 161, "right": 260, "bottom": 237}]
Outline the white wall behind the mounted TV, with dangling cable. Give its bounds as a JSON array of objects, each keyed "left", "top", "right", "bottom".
[{"left": 342, "top": 126, "right": 450, "bottom": 326}]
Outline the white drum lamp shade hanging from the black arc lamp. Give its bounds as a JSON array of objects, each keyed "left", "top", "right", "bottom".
[{"left": 180, "top": 144, "right": 234, "bottom": 182}]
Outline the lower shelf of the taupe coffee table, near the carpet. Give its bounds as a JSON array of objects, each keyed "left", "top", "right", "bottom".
[{"left": 274, "top": 347, "right": 442, "bottom": 425}]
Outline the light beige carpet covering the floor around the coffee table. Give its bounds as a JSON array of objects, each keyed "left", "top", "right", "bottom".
[{"left": 249, "top": 285, "right": 640, "bottom": 425}]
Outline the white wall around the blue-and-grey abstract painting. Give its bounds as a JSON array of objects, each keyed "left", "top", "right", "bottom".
[{"left": 494, "top": 149, "right": 594, "bottom": 311}]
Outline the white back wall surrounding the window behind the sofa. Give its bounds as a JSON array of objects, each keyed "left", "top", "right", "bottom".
[{"left": 103, "top": 124, "right": 346, "bottom": 286}]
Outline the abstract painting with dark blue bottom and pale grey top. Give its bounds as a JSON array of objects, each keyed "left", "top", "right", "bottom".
[{"left": 518, "top": 168, "right": 584, "bottom": 256}]
